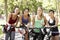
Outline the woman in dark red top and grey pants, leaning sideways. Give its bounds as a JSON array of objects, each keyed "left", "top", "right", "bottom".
[{"left": 5, "top": 6, "right": 19, "bottom": 40}]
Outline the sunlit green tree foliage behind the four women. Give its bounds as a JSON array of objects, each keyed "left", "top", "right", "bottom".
[{"left": 0, "top": 0, "right": 57, "bottom": 14}]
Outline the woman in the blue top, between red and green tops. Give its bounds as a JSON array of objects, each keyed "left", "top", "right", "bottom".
[{"left": 20, "top": 8, "right": 30, "bottom": 40}]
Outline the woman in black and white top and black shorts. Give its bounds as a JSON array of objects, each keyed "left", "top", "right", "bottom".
[{"left": 47, "top": 10, "right": 59, "bottom": 40}]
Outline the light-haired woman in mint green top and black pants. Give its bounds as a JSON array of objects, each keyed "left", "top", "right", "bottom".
[{"left": 33, "top": 7, "right": 45, "bottom": 40}]
